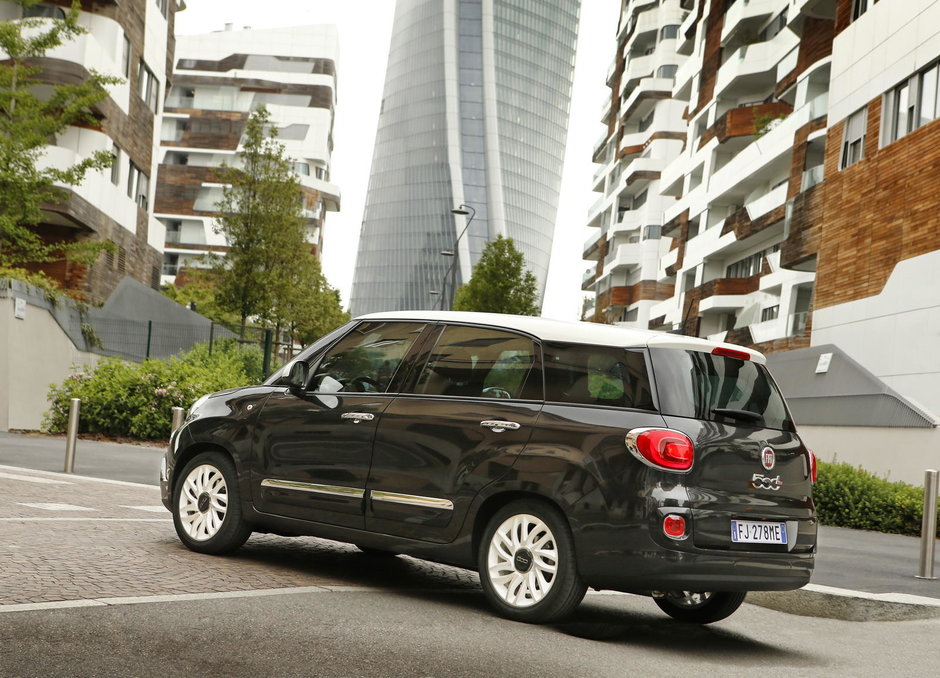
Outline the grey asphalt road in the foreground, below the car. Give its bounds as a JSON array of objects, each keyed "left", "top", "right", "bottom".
[{"left": 0, "top": 590, "right": 940, "bottom": 678}]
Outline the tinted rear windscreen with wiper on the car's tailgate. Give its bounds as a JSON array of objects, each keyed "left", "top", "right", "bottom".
[{"left": 650, "top": 348, "right": 795, "bottom": 431}]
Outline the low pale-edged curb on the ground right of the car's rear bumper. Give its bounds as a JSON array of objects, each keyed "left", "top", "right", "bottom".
[{"left": 746, "top": 584, "right": 940, "bottom": 621}]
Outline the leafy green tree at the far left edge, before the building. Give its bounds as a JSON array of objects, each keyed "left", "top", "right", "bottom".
[{"left": 0, "top": 0, "right": 121, "bottom": 282}]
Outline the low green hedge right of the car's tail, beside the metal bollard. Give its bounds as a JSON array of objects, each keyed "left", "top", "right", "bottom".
[{"left": 813, "top": 462, "right": 936, "bottom": 536}]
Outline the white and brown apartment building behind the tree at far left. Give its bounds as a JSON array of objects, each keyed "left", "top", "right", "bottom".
[{"left": 0, "top": 0, "right": 177, "bottom": 301}]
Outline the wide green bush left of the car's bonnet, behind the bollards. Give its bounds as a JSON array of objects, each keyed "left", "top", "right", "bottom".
[{"left": 43, "top": 340, "right": 262, "bottom": 440}]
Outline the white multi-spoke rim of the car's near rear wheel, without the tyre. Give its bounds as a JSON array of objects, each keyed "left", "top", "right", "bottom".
[{"left": 486, "top": 513, "right": 558, "bottom": 608}]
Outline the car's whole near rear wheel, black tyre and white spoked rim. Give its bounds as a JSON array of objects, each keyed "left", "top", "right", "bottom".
[{"left": 477, "top": 500, "right": 587, "bottom": 624}]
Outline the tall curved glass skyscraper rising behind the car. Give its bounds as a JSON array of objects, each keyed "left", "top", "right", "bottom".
[{"left": 351, "top": 0, "right": 580, "bottom": 315}]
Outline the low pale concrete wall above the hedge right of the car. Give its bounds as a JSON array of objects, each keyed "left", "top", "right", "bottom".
[{"left": 799, "top": 426, "right": 940, "bottom": 486}]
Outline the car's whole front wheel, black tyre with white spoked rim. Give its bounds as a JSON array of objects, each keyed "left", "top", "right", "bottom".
[{"left": 171, "top": 452, "right": 251, "bottom": 555}]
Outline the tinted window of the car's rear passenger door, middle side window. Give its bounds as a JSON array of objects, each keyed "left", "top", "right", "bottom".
[{"left": 415, "top": 325, "right": 541, "bottom": 399}]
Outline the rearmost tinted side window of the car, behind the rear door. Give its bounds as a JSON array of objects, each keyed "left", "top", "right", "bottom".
[{"left": 544, "top": 343, "right": 656, "bottom": 410}]
